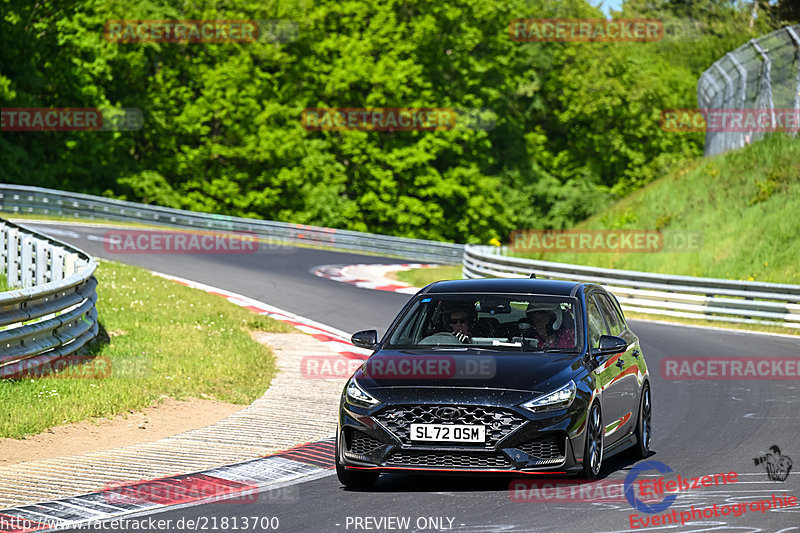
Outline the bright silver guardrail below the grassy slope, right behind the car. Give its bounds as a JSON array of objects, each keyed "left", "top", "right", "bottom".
[{"left": 463, "top": 245, "right": 800, "bottom": 328}]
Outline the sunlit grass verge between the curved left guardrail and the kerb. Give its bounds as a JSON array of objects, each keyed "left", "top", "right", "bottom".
[{"left": 0, "top": 261, "right": 293, "bottom": 438}]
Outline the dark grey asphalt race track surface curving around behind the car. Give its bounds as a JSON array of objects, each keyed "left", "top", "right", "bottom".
[{"left": 25, "top": 224, "right": 800, "bottom": 533}]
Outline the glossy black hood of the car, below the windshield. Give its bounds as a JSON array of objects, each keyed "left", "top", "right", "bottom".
[{"left": 354, "top": 350, "right": 583, "bottom": 393}]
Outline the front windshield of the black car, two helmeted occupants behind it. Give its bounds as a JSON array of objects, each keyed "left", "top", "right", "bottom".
[{"left": 387, "top": 294, "right": 582, "bottom": 352}]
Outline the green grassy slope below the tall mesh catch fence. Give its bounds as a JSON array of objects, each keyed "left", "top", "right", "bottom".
[{"left": 519, "top": 135, "right": 800, "bottom": 283}]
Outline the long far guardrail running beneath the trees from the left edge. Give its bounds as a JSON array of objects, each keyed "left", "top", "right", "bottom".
[{"left": 0, "top": 184, "right": 464, "bottom": 264}]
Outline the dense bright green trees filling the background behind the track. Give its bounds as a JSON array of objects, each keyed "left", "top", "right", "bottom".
[{"left": 0, "top": 0, "right": 783, "bottom": 242}]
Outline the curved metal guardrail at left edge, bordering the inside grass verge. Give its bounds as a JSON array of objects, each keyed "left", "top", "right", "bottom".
[{"left": 0, "top": 218, "right": 98, "bottom": 379}]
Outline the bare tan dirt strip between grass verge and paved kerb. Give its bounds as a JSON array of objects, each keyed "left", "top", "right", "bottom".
[{"left": 0, "top": 398, "right": 247, "bottom": 466}]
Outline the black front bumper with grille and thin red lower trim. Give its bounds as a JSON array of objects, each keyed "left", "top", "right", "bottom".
[{"left": 337, "top": 402, "right": 583, "bottom": 475}]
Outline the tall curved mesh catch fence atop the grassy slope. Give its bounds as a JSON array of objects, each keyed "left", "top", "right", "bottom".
[{"left": 697, "top": 24, "right": 800, "bottom": 156}]
